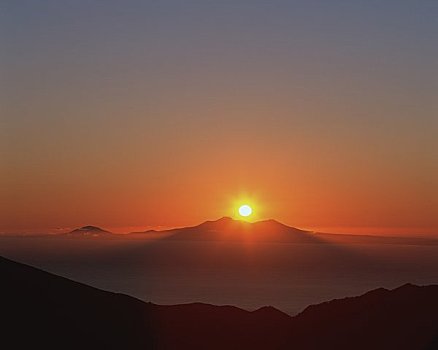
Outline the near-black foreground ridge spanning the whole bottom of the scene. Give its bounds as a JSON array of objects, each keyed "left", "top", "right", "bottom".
[{"left": 0, "top": 258, "right": 438, "bottom": 350}]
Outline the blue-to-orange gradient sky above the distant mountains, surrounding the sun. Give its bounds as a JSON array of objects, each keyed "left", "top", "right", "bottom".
[{"left": 0, "top": 0, "right": 438, "bottom": 233}]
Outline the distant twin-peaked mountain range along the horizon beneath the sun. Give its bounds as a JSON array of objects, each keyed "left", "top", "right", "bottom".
[{"left": 11, "top": 217, "right": 438, "bottom": 245}]
